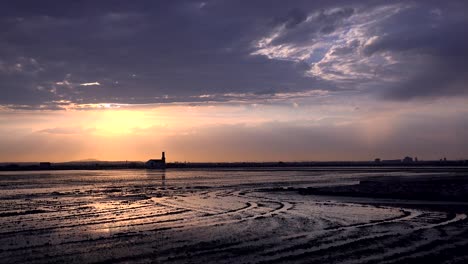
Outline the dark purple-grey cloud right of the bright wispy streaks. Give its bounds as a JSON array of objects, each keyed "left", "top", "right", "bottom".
[{"left": 363, "top": 6, "right": 468, "bottom": 100}]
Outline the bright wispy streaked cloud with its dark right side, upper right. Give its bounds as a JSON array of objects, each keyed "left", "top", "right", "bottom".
[{"left": 254, "top": 2, "right": 468, "bottom": 100}]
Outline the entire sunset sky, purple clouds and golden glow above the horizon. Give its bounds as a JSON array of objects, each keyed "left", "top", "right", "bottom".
[{"left": 0, "top": 0, "right": 468, "bottom": 162}]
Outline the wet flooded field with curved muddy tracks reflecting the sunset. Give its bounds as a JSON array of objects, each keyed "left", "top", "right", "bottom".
[{"left": 0, "top": 168, "right": 468, "bottom": 263}]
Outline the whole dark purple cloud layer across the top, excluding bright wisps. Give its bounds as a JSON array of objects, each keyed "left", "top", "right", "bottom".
[{"left": 0, "top": 1, "right": 467, "bottom": 109}]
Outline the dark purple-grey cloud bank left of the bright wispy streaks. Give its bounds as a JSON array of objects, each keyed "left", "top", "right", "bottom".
[{"left": 0, "top": 1, "right": 340, "bottom": 108}]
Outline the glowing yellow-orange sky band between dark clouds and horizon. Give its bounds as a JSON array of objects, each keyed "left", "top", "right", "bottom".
[{"left": 0, "top": 99, "right": 468, "bottom": 162}]
